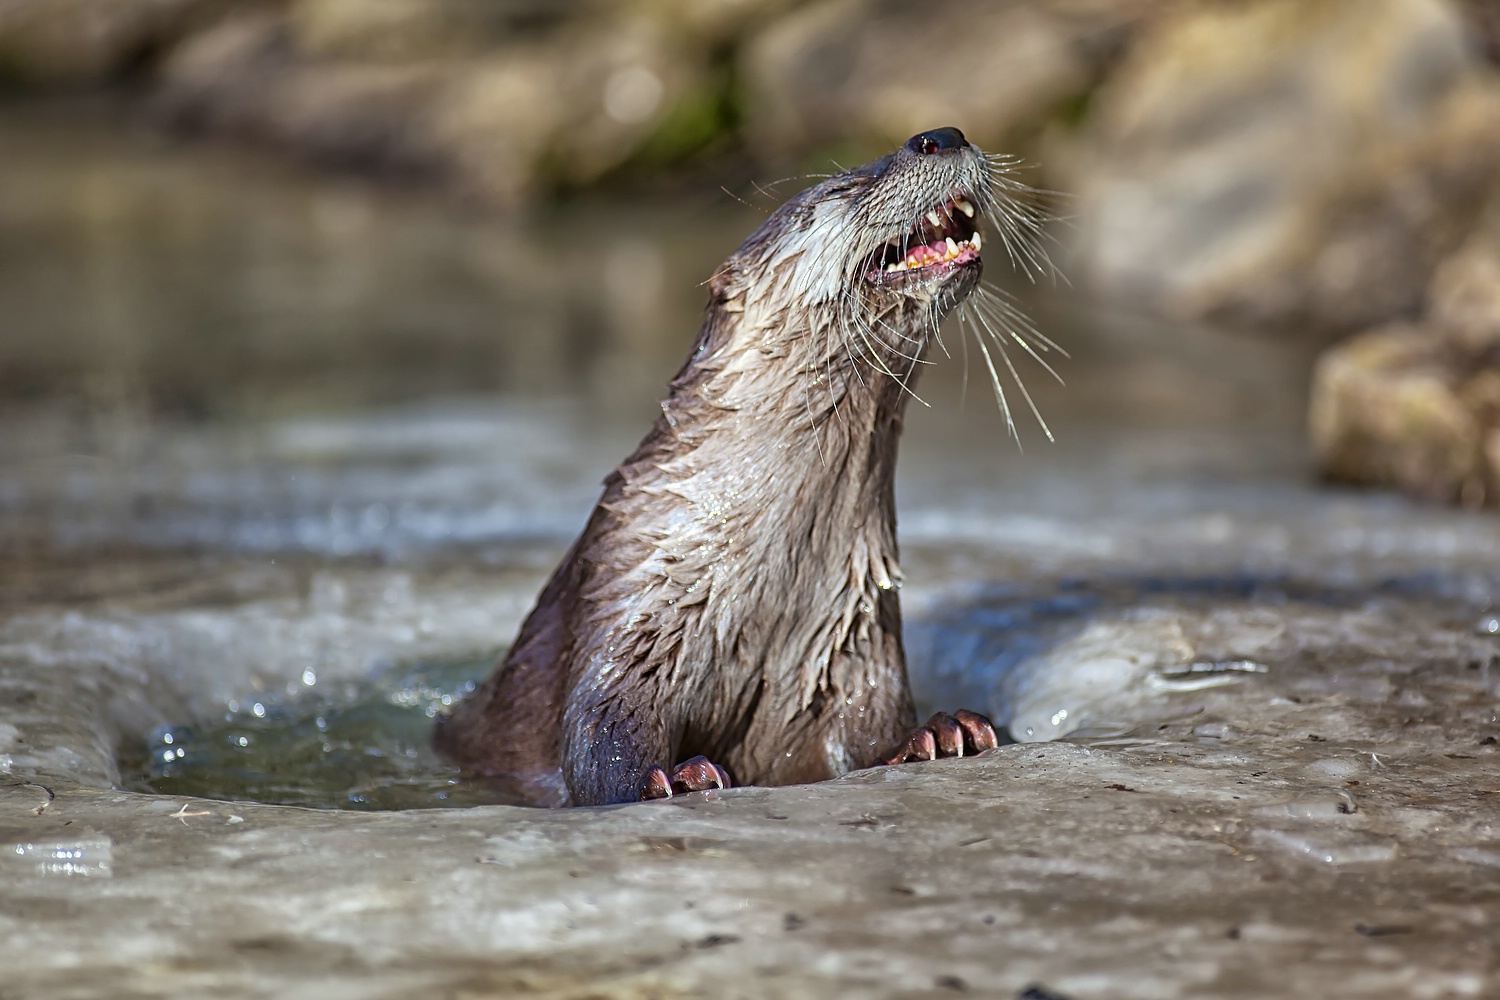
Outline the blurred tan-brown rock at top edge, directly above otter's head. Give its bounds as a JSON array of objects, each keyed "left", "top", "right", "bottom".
[{"left": 741, "top": 0, "right": 1140, "bottom": 153}]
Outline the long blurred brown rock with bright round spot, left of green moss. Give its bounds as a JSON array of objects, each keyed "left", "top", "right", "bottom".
[{"left": 156, "top": 9, "right": 708, "bottom": 205}]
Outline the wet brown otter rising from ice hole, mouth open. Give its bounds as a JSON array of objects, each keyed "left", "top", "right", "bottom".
[{"left": 434, "top": 127, "right": 1044, "bottom": 805}]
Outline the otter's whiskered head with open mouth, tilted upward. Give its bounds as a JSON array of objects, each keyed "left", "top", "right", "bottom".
[{"left": 719, "top": 127, "right": 1037, "bottom": 375}]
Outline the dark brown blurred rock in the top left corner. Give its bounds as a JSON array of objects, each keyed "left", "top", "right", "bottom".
[{"left": 0, "top": 0, "right": 222, "bottom": 87}]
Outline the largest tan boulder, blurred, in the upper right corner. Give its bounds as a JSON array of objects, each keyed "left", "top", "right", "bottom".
[{"left": 1064, "top": 0, "right": 1500, "bottom": 330}]
